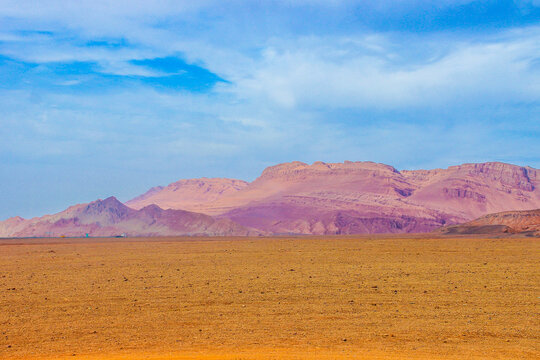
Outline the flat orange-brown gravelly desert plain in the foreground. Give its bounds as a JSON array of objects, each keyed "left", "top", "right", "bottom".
[{"left": 0, "top": 237, "right": 540, "bottom": 360}]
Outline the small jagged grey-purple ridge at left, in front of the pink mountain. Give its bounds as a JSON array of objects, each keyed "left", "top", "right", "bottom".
[{"left": 0, "top": 197, "right": 257, "bottom": 237}]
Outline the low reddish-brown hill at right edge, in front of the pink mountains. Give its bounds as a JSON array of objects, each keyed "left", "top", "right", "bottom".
[{"left": 437, "top": 209, "right": 540, "bottom": 237}]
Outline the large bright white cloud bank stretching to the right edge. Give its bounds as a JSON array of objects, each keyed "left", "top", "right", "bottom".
[{"left": 224, "top": 28, "right": 540, "bottom": 108}]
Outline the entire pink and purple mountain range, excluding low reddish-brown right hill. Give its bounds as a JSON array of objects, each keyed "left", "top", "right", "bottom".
[{"left": 0, "top": 161, "right": 540, "bottom": 237}]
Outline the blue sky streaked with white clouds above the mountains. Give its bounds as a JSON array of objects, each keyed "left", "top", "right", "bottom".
[{"left": 0, "top": 0, "right": 540, "bottom": 220}]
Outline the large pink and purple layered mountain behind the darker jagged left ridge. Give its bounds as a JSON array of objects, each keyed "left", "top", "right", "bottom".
[{"left": 127, "top": 161, "right": 540, "bottom": 234}]
